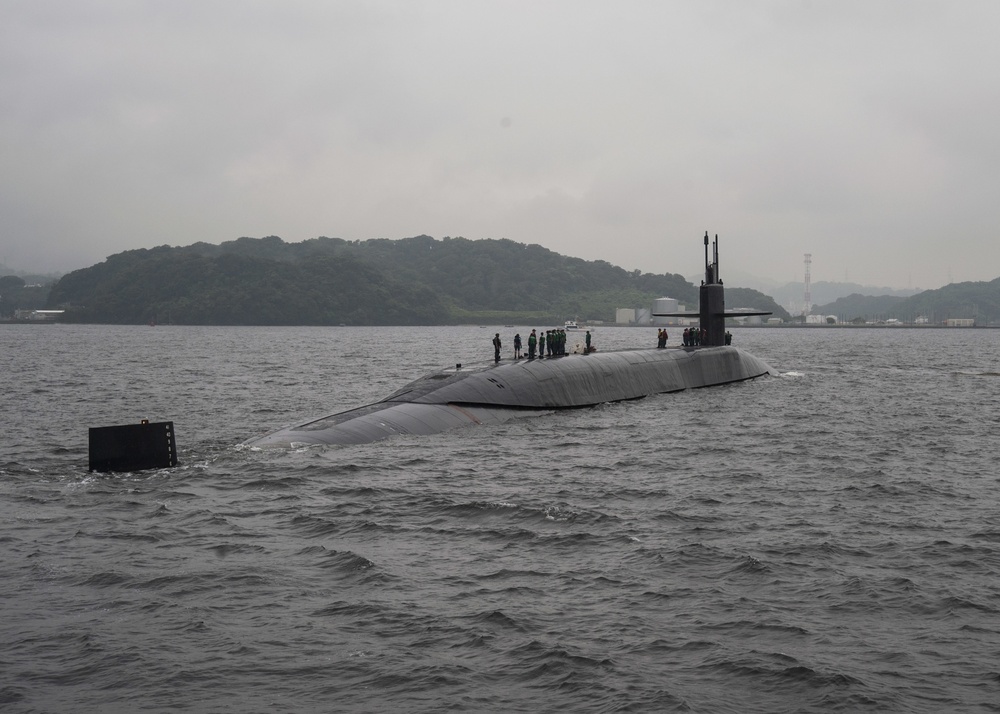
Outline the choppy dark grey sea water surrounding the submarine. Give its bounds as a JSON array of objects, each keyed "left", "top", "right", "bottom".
[{"left": 0, "top": 325, "right": 1000, "bottom": 712}]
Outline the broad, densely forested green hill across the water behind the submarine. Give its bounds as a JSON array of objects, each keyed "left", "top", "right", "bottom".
[{"left": 49, "top": 236, "right": 744, "bottom": 325}]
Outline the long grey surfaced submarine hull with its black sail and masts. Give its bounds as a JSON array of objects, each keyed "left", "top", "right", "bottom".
[{"left": 245, "top": 233, "right": 774, "bottom": 448}]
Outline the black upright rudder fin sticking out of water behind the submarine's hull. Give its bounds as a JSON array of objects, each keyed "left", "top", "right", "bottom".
[{"left": 90, "top": 419, "right": 177, "bottom": 472}]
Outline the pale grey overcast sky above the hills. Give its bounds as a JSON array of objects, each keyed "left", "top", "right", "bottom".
[{"left": 0, "top": 0, "right": 1000, "bottom": 288}]
